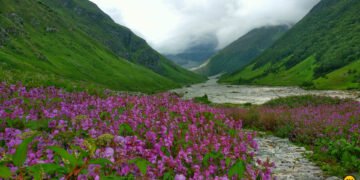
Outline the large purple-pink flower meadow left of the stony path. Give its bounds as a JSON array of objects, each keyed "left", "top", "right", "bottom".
[{"left": 0, "top": 83, "right": 273, "bottom": 180}]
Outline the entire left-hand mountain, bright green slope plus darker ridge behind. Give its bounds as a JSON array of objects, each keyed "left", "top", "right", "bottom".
[{"left": 0, "top": 0, "right": 204, "bottom": 92}]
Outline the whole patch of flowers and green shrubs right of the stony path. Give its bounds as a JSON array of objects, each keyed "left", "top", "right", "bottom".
[{"left": 227, "top": 96, "right": 360, "bottom": 176}]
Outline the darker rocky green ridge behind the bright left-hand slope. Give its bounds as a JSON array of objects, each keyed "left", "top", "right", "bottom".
[{"left": 42, "top": 0, "right": 205, "bottom": 84}]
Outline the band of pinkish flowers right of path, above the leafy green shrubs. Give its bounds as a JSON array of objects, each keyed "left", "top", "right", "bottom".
[{"left": 259, "top": 101, "right": 360, "bottom": 146}]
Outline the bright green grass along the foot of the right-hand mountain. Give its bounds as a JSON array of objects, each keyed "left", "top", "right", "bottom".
[{"left": 220, "top": 56, "right": 360, "bottom": 90}]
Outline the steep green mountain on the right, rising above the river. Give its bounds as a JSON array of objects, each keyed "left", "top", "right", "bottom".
[{"left": 220, "top": 0, "right": 360, "bottom": 89}]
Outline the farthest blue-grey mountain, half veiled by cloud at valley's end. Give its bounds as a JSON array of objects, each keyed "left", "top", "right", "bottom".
[{"left": 165, "top": 36, "right": 218, "bottom": 69}]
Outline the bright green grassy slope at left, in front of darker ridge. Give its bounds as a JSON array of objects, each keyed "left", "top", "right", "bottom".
[{"left": 0, "top": 0, "right": 183, "bottom": 92}]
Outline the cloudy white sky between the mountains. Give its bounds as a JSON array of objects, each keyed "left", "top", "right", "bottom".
[{"left": 91, "top": 0, "right": 320, "bottom": 54}]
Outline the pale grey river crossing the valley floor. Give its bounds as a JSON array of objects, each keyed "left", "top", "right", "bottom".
[{"left": 171, "top": 76, "right": 360, "bottom": 104}]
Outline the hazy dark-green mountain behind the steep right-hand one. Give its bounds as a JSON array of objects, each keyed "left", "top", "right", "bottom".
[{"left": 196, "top": 25, "right": 289, "bottom": 76}]
